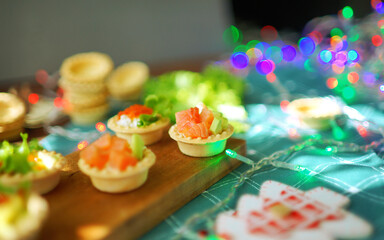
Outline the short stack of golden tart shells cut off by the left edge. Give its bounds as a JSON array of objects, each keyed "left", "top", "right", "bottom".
[{"left": 0, "top": 92, "right": 26, "bottom": 140}]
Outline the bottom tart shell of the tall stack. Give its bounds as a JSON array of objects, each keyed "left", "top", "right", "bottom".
[{"left": 66, "top": 104, "right": 109, "bottom": 125}]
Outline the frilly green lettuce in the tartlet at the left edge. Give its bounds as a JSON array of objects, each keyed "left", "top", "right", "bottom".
[{"left": 0, "top": 133, "right": 43, "bottom": 174}]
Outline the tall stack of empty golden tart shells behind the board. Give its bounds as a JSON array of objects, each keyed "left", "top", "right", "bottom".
[{"left": 59, "top": 52, "right": 114, "bottom": 125}]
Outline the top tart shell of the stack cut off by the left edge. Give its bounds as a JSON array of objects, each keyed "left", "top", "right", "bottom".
[{"left": 0, "top": 92, "right": 26, "bottom": 127}]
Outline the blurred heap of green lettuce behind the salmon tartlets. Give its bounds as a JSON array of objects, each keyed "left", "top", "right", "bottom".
[{"left": 144, "top": 65, "right": 245, "bottom": 122}]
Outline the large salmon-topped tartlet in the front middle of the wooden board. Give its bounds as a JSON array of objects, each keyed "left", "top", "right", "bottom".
[{"left": 78, "top": 134, "right": 156, "bottom": 193}]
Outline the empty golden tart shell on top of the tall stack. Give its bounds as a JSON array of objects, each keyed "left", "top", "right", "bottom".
[{"left": 60, "top": 52, "right": 113, "bottom": 83}]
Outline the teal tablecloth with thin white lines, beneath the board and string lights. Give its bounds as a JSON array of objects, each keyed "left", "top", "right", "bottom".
[{"left": 38, "top": 59, "right": 384, "bottom": 240}]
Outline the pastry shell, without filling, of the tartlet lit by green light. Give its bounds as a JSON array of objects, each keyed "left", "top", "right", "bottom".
[{"left": 169, "top": 124, "right": 234, "bottom": 157}]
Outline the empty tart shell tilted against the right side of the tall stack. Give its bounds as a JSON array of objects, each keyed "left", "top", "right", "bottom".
[{"left": 107, "top": 62, "right": 149, "bottom": 100}]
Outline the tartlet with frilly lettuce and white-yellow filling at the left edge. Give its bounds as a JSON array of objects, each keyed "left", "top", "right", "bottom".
[{"left": 0, "top": 135, "right": 64, "bottom": 194}]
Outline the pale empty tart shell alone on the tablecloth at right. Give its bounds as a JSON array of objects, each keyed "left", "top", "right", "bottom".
[{"left": 287, "top": 97, "right": 342, "bottom": 130}]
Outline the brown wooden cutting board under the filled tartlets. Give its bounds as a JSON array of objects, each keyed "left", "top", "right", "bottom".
[{"left": 40, "top": 135, "right": 246, "bottom": 240}]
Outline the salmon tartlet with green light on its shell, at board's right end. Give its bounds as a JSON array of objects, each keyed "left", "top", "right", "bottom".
[{"left": 168, "top": 106, "right": 234, "bottom": 157}]
